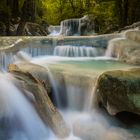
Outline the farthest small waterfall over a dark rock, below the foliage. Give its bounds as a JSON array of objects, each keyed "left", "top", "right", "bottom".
[{"left": 60, "top": 15, "right": 95, "bottom": 36}]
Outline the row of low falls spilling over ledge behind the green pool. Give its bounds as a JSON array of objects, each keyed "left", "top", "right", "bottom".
[{"left": 0, "top": 44, "right": 104, "bottom": 70}]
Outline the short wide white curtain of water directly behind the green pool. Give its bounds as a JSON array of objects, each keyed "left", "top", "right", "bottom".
[{"left": 54, "top": 45, "right": 102, "bottom": 57}]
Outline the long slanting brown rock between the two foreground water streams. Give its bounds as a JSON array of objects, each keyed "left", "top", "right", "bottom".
[{"left": 9, "top": 64, "right": 70, "bottom": 138}]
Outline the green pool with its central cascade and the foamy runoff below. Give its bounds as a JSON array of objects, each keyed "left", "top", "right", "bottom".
[{"left": 32, "top": 53, "right": 139, "bottom": 140}]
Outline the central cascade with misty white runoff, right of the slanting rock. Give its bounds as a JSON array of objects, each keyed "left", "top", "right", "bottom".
[{"left": 30, "top": 55, "right": 136, "bottom": 140}]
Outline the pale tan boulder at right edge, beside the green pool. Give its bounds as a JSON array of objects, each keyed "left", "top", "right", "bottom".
[{"left": 107, "top": 30, "right": 140, "bottom": 65}]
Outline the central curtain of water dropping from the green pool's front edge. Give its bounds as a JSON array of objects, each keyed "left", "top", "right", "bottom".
[{"left": 48, "top": 67, "right": 94, "bottom": 111}]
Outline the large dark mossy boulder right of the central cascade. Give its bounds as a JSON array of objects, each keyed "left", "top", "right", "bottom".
[{"left": 96, "top": 68, "right": 140, "bottom": 115}]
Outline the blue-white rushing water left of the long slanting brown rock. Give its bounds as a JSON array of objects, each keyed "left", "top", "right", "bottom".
[{"left": 0, "top": 74, "right": 48, "bottom": 140}]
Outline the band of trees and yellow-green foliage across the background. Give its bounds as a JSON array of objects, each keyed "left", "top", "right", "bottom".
[{"left": 0, "top": 0, "right": 140, "bottom": 32}]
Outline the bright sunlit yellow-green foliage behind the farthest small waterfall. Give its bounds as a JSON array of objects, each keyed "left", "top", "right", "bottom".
[{"left": 43, "top": 0, "right": 118, "bottom": 31}]
